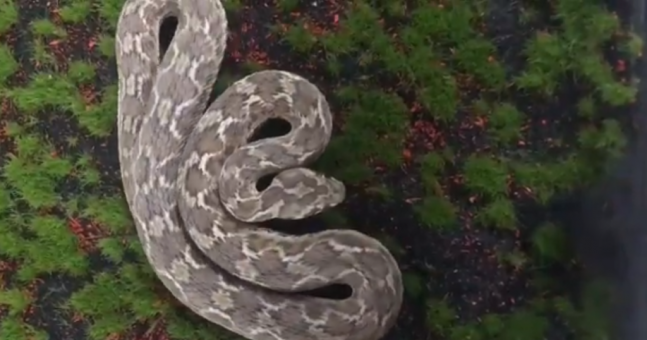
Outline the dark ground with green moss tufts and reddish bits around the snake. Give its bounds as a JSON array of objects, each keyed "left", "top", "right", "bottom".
[{"left": 0, "top": 0, "right": 642, "bottom": 340}]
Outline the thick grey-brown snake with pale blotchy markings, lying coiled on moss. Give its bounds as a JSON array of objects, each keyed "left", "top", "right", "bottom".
[{"left": 115, "top": 0, "right": 403, "bottom": 340}]
